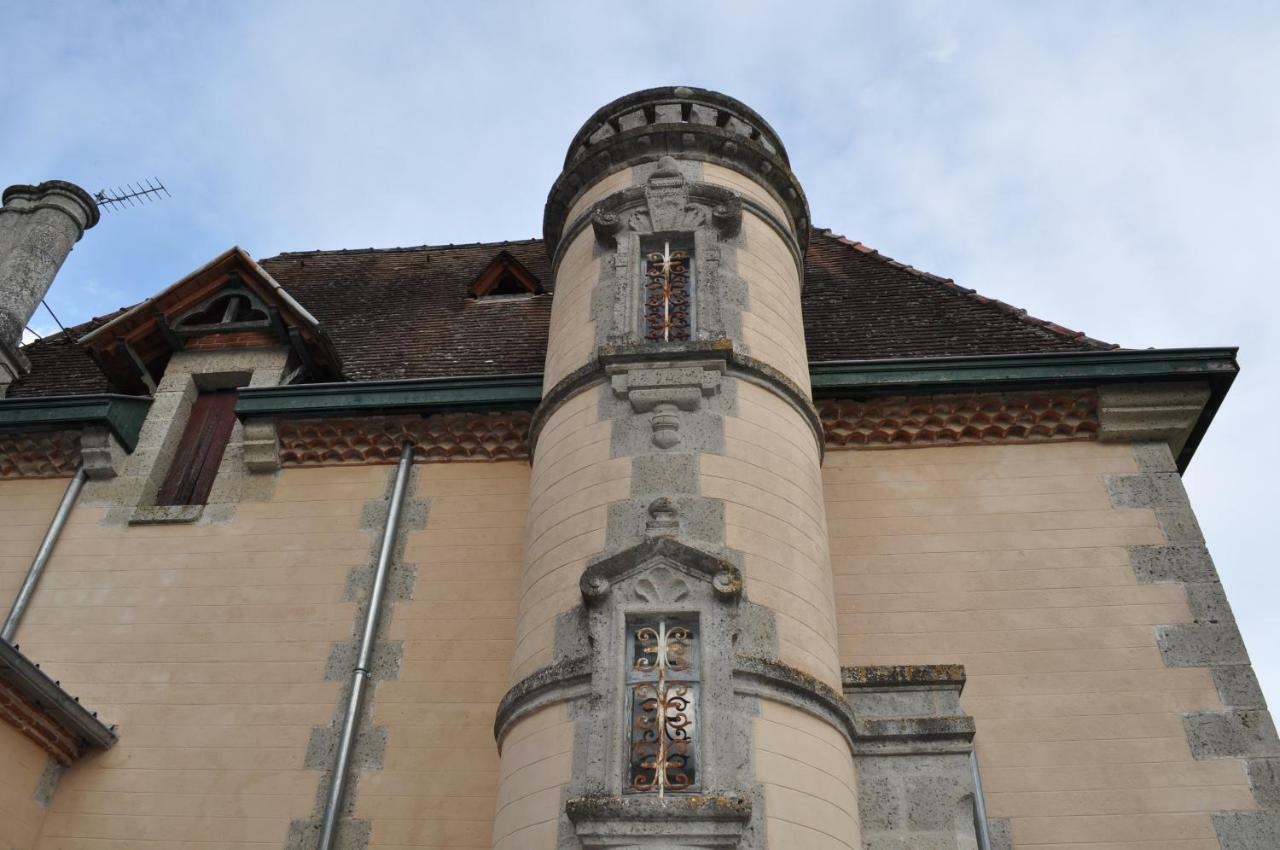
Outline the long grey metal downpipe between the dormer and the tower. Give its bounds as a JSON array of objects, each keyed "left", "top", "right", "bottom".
[{"left": 317, "top": 443, "right": 413, "bottom": 850}]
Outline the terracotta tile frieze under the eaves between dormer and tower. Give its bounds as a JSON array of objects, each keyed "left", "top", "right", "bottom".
[{"left": 276, "top": 411, "right": 530, "bottom": 466}]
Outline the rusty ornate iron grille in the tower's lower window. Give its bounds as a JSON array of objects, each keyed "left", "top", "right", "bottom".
[{"left": 627, "top": 618, "right": 698, "bottom": 798}]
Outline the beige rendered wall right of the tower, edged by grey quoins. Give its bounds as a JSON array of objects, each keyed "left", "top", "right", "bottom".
[{"left": 823, "top": 442, "right": 1256, "bottom": 850}]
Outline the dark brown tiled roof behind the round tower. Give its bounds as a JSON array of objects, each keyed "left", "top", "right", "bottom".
[{"left": 10, "top": 230, "right": 1114, "bottom": 397}]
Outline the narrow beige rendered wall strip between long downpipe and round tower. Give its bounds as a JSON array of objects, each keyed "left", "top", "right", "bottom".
[{"left": 356, "top": 461, "right": 530, "bottom": 850}]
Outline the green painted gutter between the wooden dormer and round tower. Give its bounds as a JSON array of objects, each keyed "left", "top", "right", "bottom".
[{"left": 236, "top": 375, "right": 543, "bottom": 419}]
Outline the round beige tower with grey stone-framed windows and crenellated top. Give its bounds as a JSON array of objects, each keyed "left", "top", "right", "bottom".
[{"left": 494, "top": 87, "right": 860, "bottom": 849}]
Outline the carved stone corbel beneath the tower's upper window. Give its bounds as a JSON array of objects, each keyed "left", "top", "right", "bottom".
[{"left": 609, "top": 360, "right": 727, "bottom": 449}]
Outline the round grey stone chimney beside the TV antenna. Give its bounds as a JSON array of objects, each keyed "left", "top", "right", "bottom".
[{"left": 0, "top": 180, "right": 99, "bottom": 397}]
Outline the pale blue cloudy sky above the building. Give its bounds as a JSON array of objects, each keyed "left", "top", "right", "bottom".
[{"left": 0, "top": 0, "right": 1280, "bottom": 705}]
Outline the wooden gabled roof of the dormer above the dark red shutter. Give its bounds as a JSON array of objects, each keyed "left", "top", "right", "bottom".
[{"left": 79, "top": 247, "right": 342, "bottom": 393}]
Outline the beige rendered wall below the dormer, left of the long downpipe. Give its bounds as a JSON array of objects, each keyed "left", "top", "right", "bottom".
[{"left": 0, "top": 466, "right": 389, "bottom": 850}]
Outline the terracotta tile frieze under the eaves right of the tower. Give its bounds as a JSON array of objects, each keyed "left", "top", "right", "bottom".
[{"left": 818, "top": 390, "right": 1098, "bottom": 448}]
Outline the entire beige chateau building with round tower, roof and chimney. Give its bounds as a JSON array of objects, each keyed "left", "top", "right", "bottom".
[{"left": 0, "top": 87, "right": 1280, "bottom": 850}]
